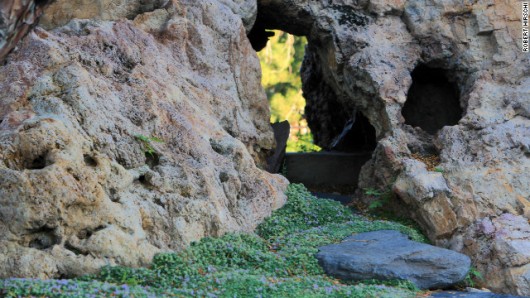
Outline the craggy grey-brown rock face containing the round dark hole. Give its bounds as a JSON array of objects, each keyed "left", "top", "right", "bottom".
[{"left": 257, "top": 0, "right": 530, "bottom": 295}]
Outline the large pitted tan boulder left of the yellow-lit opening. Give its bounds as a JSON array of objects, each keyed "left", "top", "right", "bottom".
[{"left": 0, "top": 0, "right": 287, "bottom": 278}]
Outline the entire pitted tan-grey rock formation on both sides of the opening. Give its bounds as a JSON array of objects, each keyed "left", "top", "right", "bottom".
[{"left": 0, "top": 0, "right": 530, "bottom": 295}]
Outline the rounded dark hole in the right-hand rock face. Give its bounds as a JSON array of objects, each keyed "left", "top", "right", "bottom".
[{"left": 401, "top": 64, "right": 463, "bottom": 134}]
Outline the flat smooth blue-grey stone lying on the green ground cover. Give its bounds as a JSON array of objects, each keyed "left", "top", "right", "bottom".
[{"left": 316, "top": 231, "right": 471, "bottom": 289}]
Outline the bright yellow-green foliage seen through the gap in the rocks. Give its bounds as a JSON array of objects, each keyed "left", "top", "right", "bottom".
[{"left": 258, "top": 30, "right": 321, "bottom": 152}]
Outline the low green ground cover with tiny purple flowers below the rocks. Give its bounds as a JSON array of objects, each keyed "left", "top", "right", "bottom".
[{"left": 0, "top": 184, "right": 425, "bottom": 297}]
